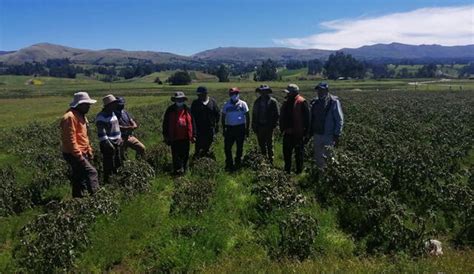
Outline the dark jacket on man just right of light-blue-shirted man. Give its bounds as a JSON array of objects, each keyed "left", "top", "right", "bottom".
[{"left": 252, "top": 96, "right": 280, "bottom": 132}]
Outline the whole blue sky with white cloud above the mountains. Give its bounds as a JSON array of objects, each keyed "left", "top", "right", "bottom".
[{"left": 0, "top": 0, "right": 474, "bottom": 55}]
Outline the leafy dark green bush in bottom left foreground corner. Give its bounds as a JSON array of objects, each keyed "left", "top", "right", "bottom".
[{"left": 14, "top": 190, "right": 117, "bottom": 273}]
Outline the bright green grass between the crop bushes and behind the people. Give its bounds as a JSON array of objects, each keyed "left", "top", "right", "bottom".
[{"left": 0, "top": 75, "right": 474, "bottom": 273}]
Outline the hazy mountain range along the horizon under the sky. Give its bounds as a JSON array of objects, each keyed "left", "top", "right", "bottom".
[{"left": 0, "top": 43, "right": 474, "bottom": 64}]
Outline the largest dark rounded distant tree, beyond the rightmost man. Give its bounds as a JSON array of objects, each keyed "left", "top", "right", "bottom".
[{"left": 324, "top": 51, "right": 366, "bottom": 79}]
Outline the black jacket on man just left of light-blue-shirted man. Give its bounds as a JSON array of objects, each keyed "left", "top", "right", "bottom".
[{"left": 191, "top": 98, "right": 220, "bottom": 134}]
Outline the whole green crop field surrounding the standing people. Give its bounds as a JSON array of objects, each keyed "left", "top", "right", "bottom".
[{"left": 0, "top": 75, "right": 474, "bottom": 273}]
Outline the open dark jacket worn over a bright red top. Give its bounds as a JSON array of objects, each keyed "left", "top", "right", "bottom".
[{"left": 162, "top": 104, "right": 196, "bottom": 142}]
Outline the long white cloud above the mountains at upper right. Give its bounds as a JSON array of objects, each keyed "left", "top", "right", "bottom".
[{"left": 273, "top": 5, "right": 474, "bottom": 50}]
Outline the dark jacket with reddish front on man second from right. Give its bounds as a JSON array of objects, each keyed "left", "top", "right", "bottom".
[{"left": 280, "top": 95, "right": 311, "bottom": 138}]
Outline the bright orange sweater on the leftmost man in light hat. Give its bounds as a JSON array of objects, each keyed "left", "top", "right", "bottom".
[{"left": 60, "top": 109, "right": 92, "bottom": 158}]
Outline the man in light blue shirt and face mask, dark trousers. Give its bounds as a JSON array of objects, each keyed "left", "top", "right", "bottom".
[{"left": 221, "top": 88, "right": 250, "bottom": 171}]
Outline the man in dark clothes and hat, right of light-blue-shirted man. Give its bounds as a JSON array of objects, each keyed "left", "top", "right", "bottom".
[{"left": 252, "top": 85, "right": 280, "bottom": 163}]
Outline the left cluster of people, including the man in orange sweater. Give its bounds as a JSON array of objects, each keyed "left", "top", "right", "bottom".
[{"left": 60, "top": 92, "right": 145, "bottom": 197}]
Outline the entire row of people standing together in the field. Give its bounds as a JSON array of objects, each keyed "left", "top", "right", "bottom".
[{"left": 61, "top": 82, "right": 344, "bottom": 197}]
